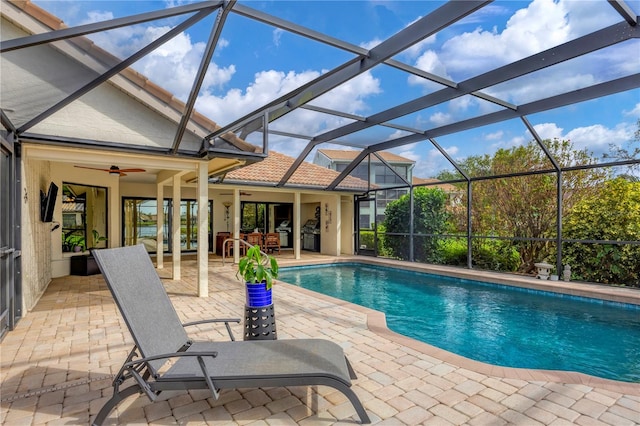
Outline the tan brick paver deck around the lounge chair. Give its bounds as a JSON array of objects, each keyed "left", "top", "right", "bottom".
[{"left": 0, "top": 255, "right": 640, "bottom": 426}]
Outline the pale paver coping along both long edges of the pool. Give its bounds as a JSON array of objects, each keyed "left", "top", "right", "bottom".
[{"left": 279, "top": 257, "right": 640, "bottom": 396}]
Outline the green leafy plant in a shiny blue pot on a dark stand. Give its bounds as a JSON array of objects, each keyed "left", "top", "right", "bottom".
[{"left": 236, "top": 245, "right": 278, "bottom": 308}]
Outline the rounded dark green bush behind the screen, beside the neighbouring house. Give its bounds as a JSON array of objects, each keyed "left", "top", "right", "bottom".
[{"left": 383, "top": 187, "right": 448, "bottom": 262}]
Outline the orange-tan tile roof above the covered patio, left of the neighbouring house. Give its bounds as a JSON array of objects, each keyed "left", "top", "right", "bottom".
[{"left": 224, "top": 151, "right": 368, "bottom": 192}]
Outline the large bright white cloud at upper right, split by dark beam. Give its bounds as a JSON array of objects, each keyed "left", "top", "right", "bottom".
[{"left": 408, "top": 0, "right": 604, "bottom": 123}]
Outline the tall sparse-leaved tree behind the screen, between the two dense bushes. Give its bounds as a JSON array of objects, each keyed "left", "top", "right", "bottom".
[{"left": 440, "top": 139, "right": 607, "bottom": 273}]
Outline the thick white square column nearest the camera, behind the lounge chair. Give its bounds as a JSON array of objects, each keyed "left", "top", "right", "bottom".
[{"left": 198, "top": 161, "right": 209, "bottom": 297}]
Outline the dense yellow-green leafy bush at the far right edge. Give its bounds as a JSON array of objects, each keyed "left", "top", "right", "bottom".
[{"left": 563, "top": 178, "right": 640, "bottom": 287}]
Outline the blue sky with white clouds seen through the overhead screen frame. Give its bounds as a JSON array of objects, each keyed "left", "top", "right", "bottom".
[{"left": 35, "top": 0, "right": 640, "bottom": 177}]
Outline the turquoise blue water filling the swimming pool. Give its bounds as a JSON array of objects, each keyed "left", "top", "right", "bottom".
[{"left": 279, "top": 264, "right": 640, "bottom": 382}]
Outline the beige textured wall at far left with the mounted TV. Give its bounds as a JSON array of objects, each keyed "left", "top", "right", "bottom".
[{"left": 20, "top": 158, "right": 52, "bottom": 315}]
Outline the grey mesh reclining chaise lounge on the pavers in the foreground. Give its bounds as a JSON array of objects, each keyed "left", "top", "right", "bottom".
[{"left": 92, "top": 245, "right": 370, "bottom": 425}]
